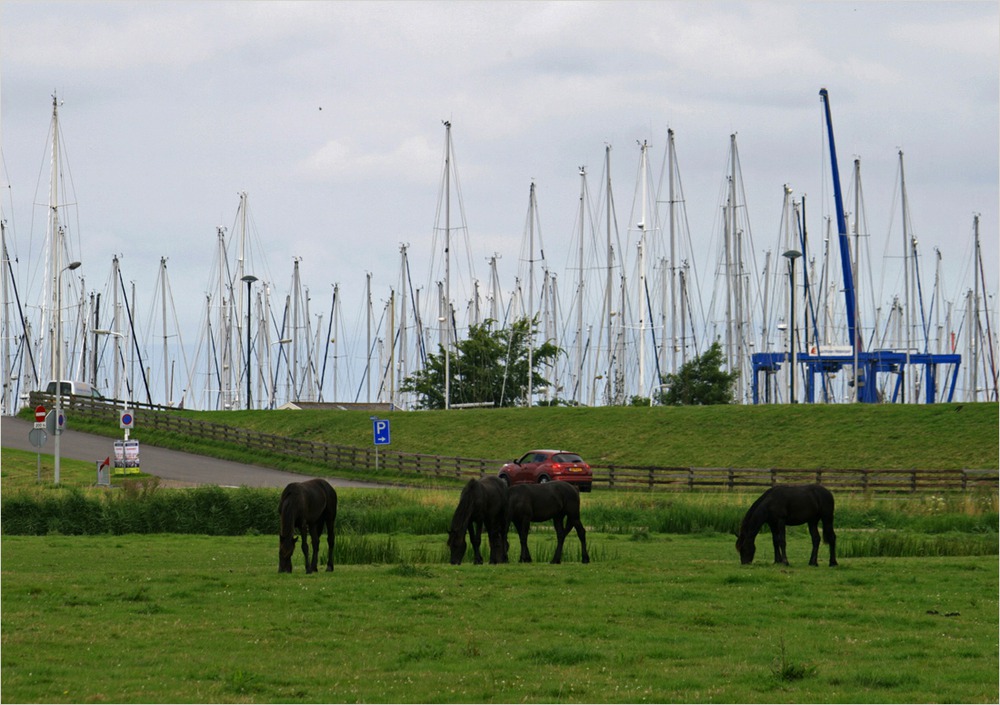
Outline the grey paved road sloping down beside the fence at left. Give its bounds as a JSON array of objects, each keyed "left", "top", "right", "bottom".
[{"left": 0, "top": 416, "right": 385, "bottom": 487}]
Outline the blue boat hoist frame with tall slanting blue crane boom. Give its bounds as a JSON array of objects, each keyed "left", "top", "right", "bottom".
[{"left": 751, "top": 88, "right": 962, "bottom": 404}]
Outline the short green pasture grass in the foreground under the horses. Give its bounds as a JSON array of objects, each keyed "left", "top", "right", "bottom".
[{"left": 2, "top": 530, "right": 1000, "bottom": 703}]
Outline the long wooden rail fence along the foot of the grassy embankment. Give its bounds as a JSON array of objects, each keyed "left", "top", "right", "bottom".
[{"left": 31, "top": 393, "right": 1000, "bottom": 493}]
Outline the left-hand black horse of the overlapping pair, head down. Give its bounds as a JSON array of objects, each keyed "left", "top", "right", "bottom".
[{"left": 448, "top": 477, "right": 507, "bottom": 565}]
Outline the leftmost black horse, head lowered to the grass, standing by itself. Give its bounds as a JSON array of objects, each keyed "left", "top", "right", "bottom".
[{"left": 278, "top": 478, "right": 337, "bottom": 573}]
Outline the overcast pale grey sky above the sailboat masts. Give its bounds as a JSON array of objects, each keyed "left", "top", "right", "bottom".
[{"left": 0, "top": 0, "right": 1000, "bottom": 396}]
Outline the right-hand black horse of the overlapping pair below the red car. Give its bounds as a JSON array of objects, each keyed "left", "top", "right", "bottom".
[{"left": 509, "top": 482, "right": 590, "bottom": 563}]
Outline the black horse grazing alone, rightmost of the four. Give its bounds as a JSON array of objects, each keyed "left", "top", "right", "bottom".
[{"left": 736, "top": 485, "right": 837, "bottom": 566}]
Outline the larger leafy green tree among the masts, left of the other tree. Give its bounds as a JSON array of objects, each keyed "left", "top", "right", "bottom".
[{"left": 400, "top": 318, "right": 561, "bottom": 409}]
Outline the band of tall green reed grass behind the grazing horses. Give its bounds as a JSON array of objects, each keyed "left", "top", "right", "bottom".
[{"left": 0, "top": 479, "right": 998, "bottom": 563}]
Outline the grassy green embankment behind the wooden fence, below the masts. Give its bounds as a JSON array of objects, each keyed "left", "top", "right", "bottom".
[{"left": 39, "top": 404, "right": 1000, "bottom": 484}]
